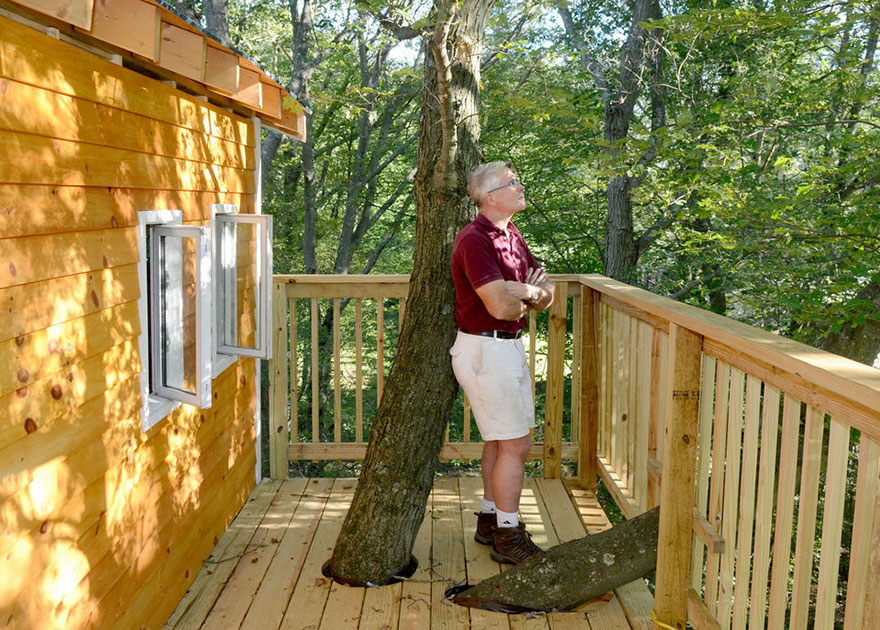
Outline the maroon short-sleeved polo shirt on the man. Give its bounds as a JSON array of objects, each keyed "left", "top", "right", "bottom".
[{"left": 452, "top": 214, "right": 538, "bottom": 332}]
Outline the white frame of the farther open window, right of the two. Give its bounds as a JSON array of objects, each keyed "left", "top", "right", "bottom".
[{"left": 211, "top": 204, "right": 272, "bottom": 360}]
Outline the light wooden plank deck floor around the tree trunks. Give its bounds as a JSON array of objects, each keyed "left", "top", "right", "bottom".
[{"left": 165, "top": 477, "right": 653, "bottom": 630}]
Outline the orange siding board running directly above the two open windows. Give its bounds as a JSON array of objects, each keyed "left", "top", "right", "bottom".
[{"left": 0, "top": 184, "right": 254, "bottom": 238}]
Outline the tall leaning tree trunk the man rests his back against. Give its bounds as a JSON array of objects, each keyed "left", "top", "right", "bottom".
[{"left": 327, "top": 0, "right": 493, "bottom": 584}]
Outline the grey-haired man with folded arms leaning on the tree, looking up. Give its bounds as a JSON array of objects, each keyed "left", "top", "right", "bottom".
[{"left": 449, "top": 162, "right": 553, "bottom": 564}]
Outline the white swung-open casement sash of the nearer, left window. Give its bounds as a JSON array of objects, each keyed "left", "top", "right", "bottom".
[{"left": 149, "top": 225, "right": 211, "bottom": 408}]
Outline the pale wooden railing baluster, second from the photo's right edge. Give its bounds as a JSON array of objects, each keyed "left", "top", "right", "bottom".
[{"left": 813, "top": 418, "right": 849, "bottom": 628}]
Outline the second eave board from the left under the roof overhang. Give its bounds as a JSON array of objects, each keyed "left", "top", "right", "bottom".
[{"left": 90, "top": 0, "right": 161, "bottom": 61}]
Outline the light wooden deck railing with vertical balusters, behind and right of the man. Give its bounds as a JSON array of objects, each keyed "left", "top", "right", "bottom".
[{"left": 270, "top": 276, "right": 880, "bottom": 630}]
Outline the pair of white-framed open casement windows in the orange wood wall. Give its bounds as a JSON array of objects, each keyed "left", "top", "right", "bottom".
[{"left": 138, "top": 204, "right": 272, "bottom": 431}]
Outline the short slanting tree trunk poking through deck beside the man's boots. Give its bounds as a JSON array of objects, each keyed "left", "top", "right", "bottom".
[{"left": 452, "top": 507, "right": 660, "bottom": 612}]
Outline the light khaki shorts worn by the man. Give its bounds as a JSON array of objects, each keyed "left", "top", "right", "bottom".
[{"left": 449, "top": 331, "right": 535, "bottom": 442}]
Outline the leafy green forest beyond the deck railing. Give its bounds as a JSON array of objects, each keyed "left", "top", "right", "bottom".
[{"left": 168, "top": 0, "right": 880, "bottom": 464}]
